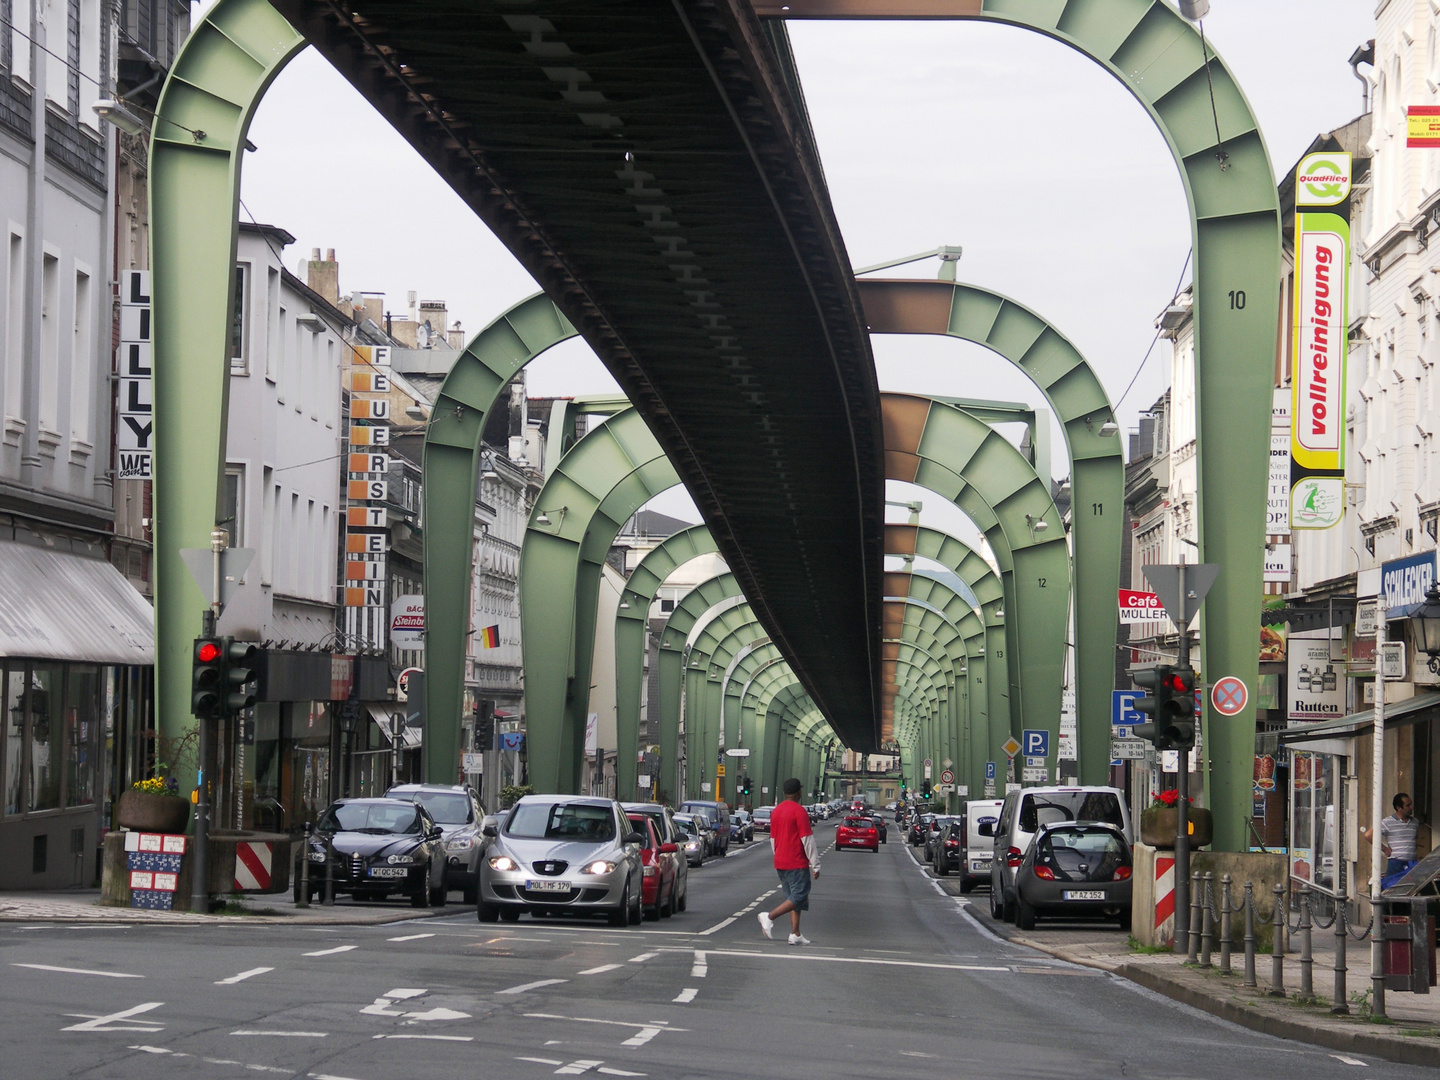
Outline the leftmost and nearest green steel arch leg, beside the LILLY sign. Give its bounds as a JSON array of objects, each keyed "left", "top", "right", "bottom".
[{"left": 150, "top": 0, "right": 305, "bottom": 786}]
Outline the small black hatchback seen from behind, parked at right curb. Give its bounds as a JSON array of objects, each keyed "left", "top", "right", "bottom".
[{"left": 1015, "top": 821, "right": 1135, "bottom": 930}]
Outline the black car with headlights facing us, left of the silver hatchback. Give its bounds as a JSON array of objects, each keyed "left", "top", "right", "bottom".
[{"left": 295, "top": 799, "right": 445, "bottom": 907}]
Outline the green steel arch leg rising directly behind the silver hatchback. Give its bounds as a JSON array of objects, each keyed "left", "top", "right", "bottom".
[{"left": 524, "top": 409, "right": 680, "bottom": 791}]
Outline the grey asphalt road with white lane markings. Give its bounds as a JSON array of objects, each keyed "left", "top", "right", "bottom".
[{"left": 0, "top": 827, "right": 1440, "bottom": 1080}]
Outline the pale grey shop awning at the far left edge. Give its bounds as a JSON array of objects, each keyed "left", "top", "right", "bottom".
[{"left": 0, "top": 541, "right": 156, "bottom": 664}]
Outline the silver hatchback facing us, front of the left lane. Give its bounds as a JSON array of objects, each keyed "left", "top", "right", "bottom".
[{"left": 475, "top": 795, "right": 641, "bottom": 926}]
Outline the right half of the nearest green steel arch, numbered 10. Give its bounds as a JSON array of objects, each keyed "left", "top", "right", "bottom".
[{"left": 753, "top": 0, "right": 1280, "bottom": 851}]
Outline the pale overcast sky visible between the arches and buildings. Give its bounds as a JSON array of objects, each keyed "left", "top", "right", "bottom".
[{"left": 242, "top": 0, "right": 1374, "bottom": 524}]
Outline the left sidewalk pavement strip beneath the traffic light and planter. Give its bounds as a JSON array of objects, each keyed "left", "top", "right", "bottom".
[{"left": 0, "top": 888, "right": 464, "bottom": 926}]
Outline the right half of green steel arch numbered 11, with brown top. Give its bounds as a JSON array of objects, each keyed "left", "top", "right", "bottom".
[{"left": 858, "top": 278, "right": 1126, "bottom": 783}]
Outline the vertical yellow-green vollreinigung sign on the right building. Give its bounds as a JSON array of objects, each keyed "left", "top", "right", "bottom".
[{"left": 1290, "top": 153, "right": 1351, "bottom": 528}]
